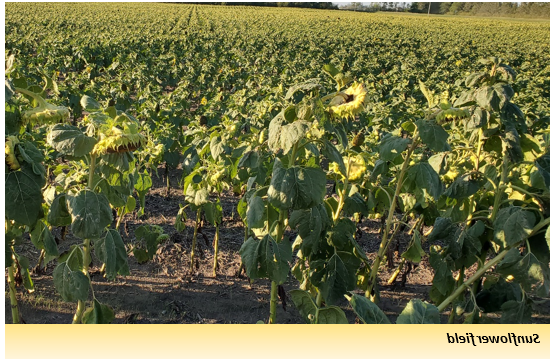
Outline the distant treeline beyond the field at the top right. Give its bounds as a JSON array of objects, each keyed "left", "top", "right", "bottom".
[{"left": 340, "top": 2, "right": 550, "bottom": 18}]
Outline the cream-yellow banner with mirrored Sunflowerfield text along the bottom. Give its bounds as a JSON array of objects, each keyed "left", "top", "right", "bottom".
[{"left": 5, "top": 324, "right": 550, "bottom": 359}]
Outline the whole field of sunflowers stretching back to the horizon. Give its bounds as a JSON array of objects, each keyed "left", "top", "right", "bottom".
[{"left": 4, "top": 3, "right": 550, "bottom": 324}]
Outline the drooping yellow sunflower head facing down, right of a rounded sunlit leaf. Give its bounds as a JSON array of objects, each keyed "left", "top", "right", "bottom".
[{"left": 92, "top": 122, "right": 147, "bottom": 155}]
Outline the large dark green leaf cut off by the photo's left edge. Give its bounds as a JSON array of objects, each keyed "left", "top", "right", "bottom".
[{"left": 5, "top": 163, "right": 45, "bottom": 226}]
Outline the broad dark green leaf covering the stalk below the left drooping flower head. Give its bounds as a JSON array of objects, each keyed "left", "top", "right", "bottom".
[{"left": 66, "top": 190, "right": 113, "bottom": 239}]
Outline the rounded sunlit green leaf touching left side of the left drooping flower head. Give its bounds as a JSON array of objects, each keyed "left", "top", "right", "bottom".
[{"left": 46, "top": 124, "right": 96, "bottom": 157}]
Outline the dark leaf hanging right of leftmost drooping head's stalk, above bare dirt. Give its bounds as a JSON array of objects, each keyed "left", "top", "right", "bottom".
[{"left": 94, "top": 229, "right": 130, "bottom": 280}]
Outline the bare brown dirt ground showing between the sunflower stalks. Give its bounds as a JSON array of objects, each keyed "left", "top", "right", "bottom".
[{"left": 5, "top": 168, "right": 550, "bottom": 324}]
